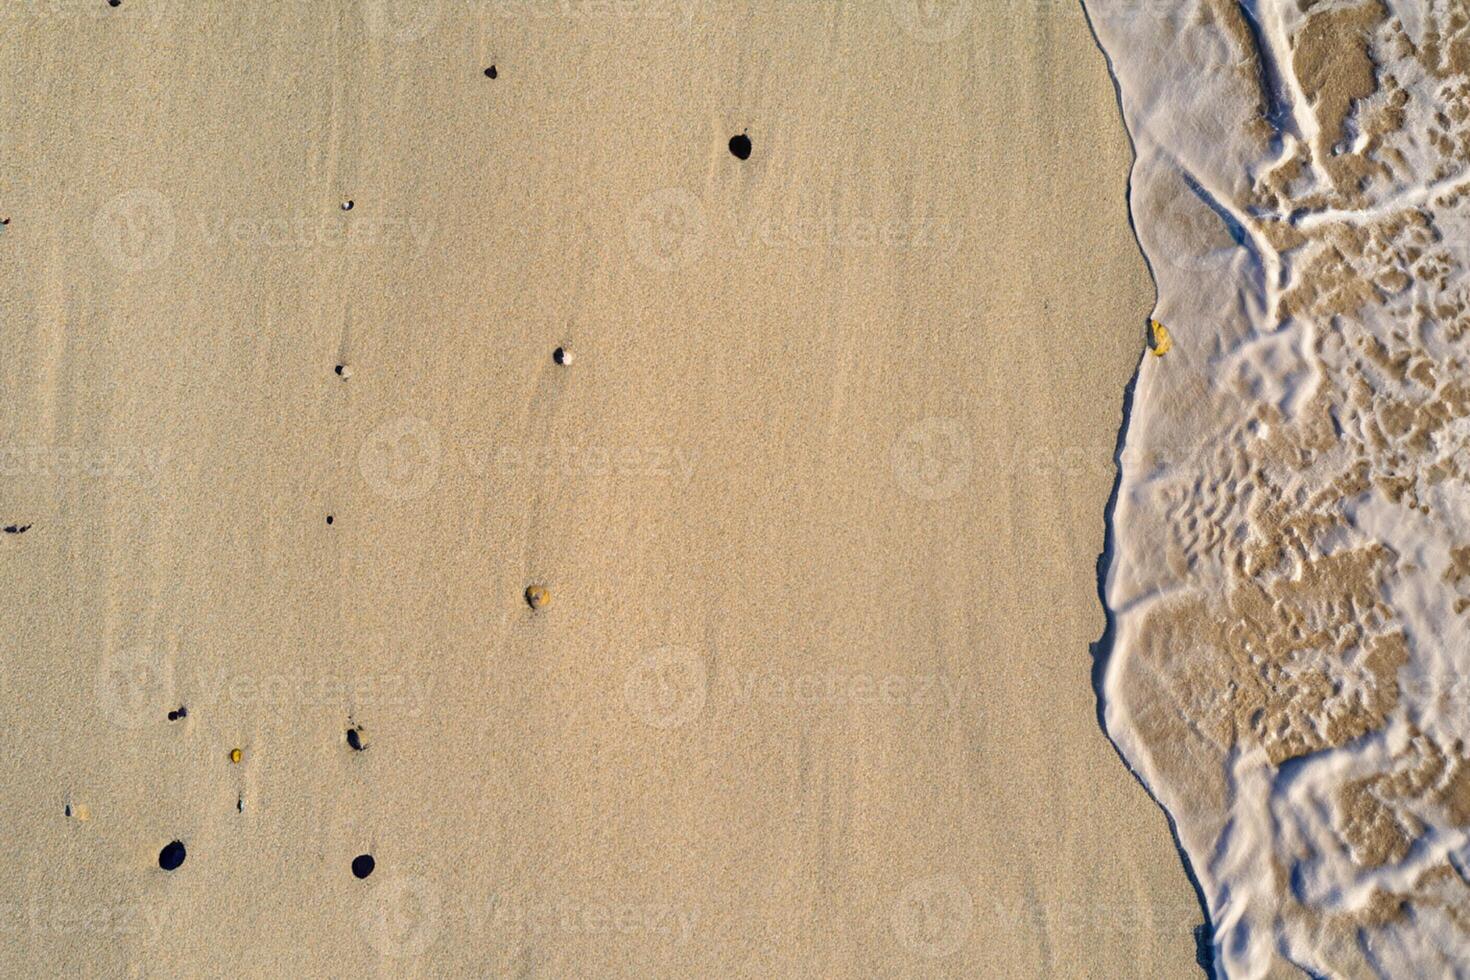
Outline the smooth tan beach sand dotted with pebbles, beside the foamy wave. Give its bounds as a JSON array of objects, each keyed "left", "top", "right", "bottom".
[{"left": 0, "top": 0, "right": 1200, "bottom": 977}]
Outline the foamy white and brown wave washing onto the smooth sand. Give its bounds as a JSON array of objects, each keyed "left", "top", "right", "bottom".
[{"left": 1088, "top": 0, "right": 1470, "bottom": 976}]
